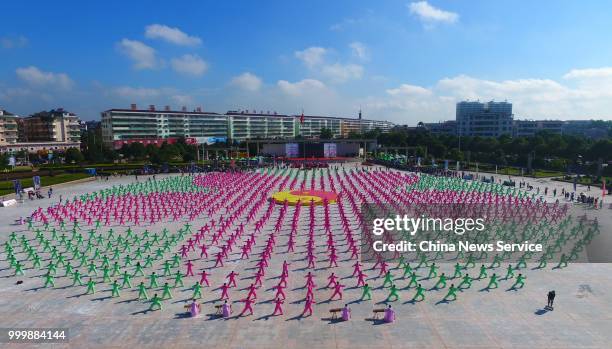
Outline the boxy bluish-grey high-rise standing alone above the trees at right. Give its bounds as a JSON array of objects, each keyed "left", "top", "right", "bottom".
[{"left": 456, "top": 101, "right": 514, "bottom": 137}]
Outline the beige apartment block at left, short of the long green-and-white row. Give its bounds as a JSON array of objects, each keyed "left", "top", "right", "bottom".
[{"left": 18, "top": 108, "right": 81, "bottom": 142}]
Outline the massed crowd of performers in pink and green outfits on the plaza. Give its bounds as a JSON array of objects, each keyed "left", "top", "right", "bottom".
[{"left": 3, "top": 167, "right": 599, "bottom": 321}]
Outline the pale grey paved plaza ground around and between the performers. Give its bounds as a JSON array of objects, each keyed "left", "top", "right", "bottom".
[{"left": 0, "top": 164, "right": 612, "bottom": 349}]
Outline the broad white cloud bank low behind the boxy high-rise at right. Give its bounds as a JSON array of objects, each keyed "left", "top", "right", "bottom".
[{"left": 364, "top": 68, "right": 612, "bottom": 125}]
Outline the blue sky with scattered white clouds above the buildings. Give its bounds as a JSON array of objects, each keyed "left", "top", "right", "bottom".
[{"left": 0, "top": 0, "right": 612, "bottom": 125}]
